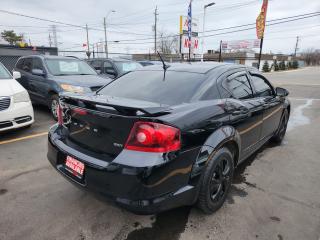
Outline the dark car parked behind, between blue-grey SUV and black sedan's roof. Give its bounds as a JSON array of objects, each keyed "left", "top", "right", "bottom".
[{"left": 87, "top": 58, "right": 142, "bottom": 79}]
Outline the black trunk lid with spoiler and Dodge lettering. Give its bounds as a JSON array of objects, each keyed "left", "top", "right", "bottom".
[{"left": 61, "top": 95, "right": 170, "bottom": 157}]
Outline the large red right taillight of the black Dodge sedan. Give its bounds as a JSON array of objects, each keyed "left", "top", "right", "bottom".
[{"left": 125, "top": 122, "right": 181, "bottom": 153}]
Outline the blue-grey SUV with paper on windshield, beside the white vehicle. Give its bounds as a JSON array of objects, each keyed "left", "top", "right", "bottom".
[{"left": 14, "top": 55, "right": 111, "bottom": 119}]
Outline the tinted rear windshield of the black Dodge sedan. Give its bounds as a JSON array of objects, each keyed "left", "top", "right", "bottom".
[{"left": 99, "top": 71, "right": 204, "bottom": 105}]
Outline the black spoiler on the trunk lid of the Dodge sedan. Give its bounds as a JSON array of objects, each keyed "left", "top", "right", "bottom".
[{"left": 59, "top": 94, "right": 172, "bottom": 116}]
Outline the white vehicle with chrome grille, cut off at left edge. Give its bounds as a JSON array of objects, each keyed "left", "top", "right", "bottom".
[{"left": 0, "top": 63, "right": 34, "bottom": 132}]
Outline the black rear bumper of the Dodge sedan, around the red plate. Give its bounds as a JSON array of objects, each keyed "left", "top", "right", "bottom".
[{"left": 47, "top": 125, "right": 198, "bottom": 214}]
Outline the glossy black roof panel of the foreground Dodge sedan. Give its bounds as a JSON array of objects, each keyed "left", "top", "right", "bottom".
[{"left": 135, "top": 62, "right": 245, "bottom": 74}]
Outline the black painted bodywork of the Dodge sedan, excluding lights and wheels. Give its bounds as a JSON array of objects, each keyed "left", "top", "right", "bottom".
[{"left": 47, "top": 64, "right": 290, "bottom": 214}]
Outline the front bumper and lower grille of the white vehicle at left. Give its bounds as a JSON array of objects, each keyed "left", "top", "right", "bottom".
[{"left": 0, "top": 101, "right": 34, "bottom": 132}]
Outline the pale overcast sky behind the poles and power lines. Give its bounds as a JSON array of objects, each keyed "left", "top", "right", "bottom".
[{"left": 0, "top": 0, "right": 320, "bottom": 57}]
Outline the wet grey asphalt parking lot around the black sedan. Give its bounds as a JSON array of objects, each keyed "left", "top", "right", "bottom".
[{"left": 0, "top": 68, "right": 320, "bottom": 240}]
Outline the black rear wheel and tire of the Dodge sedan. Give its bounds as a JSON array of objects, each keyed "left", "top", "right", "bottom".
[{"left": 197, "top": 147, "right": 234, "bottom": 214}]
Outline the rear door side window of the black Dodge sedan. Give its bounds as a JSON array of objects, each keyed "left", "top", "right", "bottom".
[{"left": 225, "top": 75, "right": 253, "bottom": 99}]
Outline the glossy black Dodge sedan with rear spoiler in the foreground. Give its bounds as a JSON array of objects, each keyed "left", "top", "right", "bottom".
[{"left": 47, "top": 63, "right": 290, "bottom": 213}]
